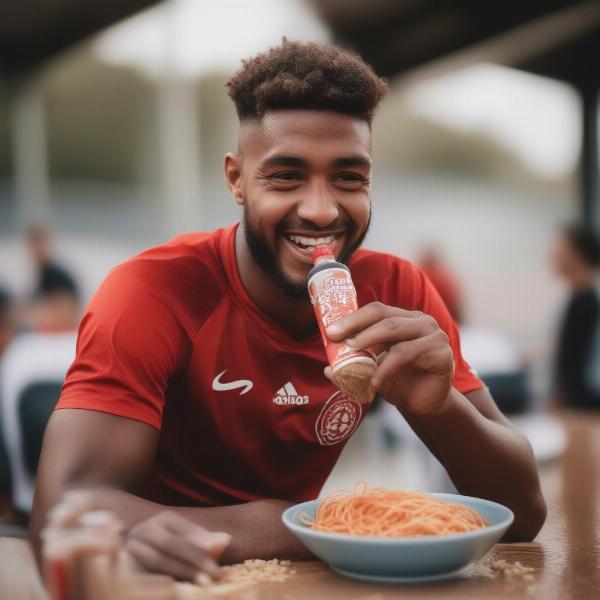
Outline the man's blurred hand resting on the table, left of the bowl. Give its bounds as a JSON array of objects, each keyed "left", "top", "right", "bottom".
[{"left": 125, "top": 511, "right": 231, "bottom": 585}]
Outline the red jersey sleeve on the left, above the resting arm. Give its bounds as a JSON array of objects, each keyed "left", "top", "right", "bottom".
[{"left": 56, "top": 263, "right": 189, "bottom": 429}]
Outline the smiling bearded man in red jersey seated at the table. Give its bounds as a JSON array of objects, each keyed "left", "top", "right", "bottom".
[{"left": 32, "top": 41, "right": 545, "bottom": 579}]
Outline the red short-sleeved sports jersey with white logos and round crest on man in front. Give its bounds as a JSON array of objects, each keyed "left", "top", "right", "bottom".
[{"left": 57, "top": 226, "right": 483, "bottom": 506}]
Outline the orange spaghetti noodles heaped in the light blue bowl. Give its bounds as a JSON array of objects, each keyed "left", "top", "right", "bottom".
[{"left": 303, "top": 486, "right": 487, "bottom": 537}]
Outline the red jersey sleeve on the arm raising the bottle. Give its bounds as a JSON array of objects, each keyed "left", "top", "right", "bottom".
[{"left": 397, "top": 262, "right": 485, "bottom": 394}]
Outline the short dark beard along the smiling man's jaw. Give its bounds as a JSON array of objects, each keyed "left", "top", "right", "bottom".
[{"left": 243, "top": 204, "right": 371, "bottom": 302}]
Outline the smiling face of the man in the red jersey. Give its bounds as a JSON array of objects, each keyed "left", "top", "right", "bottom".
[{"left": 236, "top": 110, "right": 371, "bottom": 298}]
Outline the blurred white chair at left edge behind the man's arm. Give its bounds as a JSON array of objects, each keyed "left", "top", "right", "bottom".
[{"left": 0, "top": 332, "right": 76, "bottom": 512}]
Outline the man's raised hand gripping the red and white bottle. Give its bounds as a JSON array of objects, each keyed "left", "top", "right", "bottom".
[{"left": 325, "top": 302, "right": 454, "bottom": 415}]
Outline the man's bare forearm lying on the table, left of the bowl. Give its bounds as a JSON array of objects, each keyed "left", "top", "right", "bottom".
[{"left": 65, "top": 489, "right": 310, "bottom": 563}]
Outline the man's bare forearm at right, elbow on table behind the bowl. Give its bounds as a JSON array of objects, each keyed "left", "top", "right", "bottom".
[{"left": 405, "top": 389, "right": 545, "bottom": 540}]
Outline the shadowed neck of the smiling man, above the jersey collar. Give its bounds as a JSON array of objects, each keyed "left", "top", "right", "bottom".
[{"left": 235, "top": 225, "right": 317, "bottom": 340}]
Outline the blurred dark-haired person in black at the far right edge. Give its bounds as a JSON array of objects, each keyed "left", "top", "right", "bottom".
[{"left": 551, "top": 225, "right": 600, "bottom": 409}]
